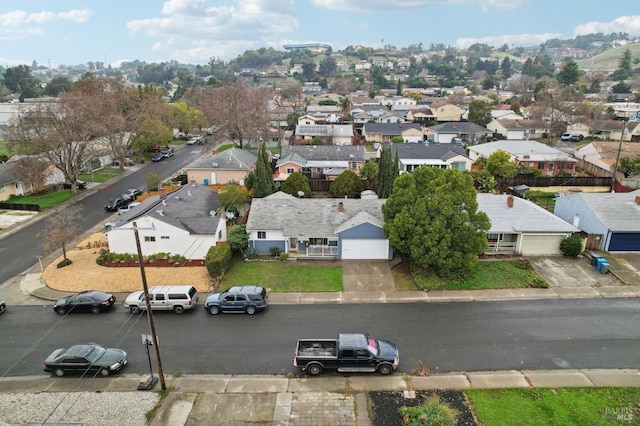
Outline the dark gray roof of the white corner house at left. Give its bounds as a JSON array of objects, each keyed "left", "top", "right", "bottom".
[{"left": 116, "top": 182, "right": 221, "bottom": 235}]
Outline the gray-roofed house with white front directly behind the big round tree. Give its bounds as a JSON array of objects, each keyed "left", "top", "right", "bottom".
[{"left": 377, "top": 143, "right": 473, "bottom": 174}]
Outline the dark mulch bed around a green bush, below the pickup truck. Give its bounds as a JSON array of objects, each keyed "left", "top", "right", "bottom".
[{"left": 369, "top": 390, "right": 478, "bottom": 426}]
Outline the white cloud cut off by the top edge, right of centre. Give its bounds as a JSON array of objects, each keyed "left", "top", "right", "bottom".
[{"left": 310, "top": 0, "right": 531, "bottom": 12}]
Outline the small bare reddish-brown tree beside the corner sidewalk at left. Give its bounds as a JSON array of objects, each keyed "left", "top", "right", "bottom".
[{"left": 38, "top": 205, "right": 81, "bottom": 261}]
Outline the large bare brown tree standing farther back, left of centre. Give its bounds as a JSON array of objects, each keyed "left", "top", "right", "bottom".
[{"left": 187, "top": 81, "right": 269, "bottom": 148}]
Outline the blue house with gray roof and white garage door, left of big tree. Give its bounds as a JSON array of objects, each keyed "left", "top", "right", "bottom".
[{"left": 246, "top": 192, "right": 393, "bottom": 260}]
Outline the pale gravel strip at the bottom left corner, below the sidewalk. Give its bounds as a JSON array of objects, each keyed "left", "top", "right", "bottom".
[{"left": 0, "top": 392, "right": 160, "bottom": 426}]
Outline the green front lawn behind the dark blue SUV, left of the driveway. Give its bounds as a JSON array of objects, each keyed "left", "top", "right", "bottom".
[{"left": 222, "top": 260, "right": 342, "bottom": 292}]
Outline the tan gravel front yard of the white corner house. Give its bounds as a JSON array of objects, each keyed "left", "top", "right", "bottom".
[{"left": 43, "top": 233, "right": 214, "bottom": 293}]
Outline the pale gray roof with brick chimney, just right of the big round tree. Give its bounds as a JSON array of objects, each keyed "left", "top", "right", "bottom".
[{"left": 476, "top": 193, "right": 580, "bottom": 233}]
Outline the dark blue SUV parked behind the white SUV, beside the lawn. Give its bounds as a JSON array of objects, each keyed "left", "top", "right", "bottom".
[{"left": 204, "top": 285, "right": 269, "bottom": 315}]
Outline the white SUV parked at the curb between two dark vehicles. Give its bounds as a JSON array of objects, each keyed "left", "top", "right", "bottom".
[{"left": 124, "top": 285, "right": 198, "bottom": 314}]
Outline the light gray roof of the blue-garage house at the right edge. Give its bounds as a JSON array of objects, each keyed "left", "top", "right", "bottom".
[{"left": 568, "top": 190, "right": 640, "bottom": 232}]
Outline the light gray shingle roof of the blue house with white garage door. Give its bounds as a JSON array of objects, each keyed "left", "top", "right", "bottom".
[{"left": 246, "top": 192, "right": 386, "bottom": 238}]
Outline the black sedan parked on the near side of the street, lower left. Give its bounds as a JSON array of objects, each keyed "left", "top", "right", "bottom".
[{"left": 42, "top": 343, "right": 127, "bottom": 377}]
